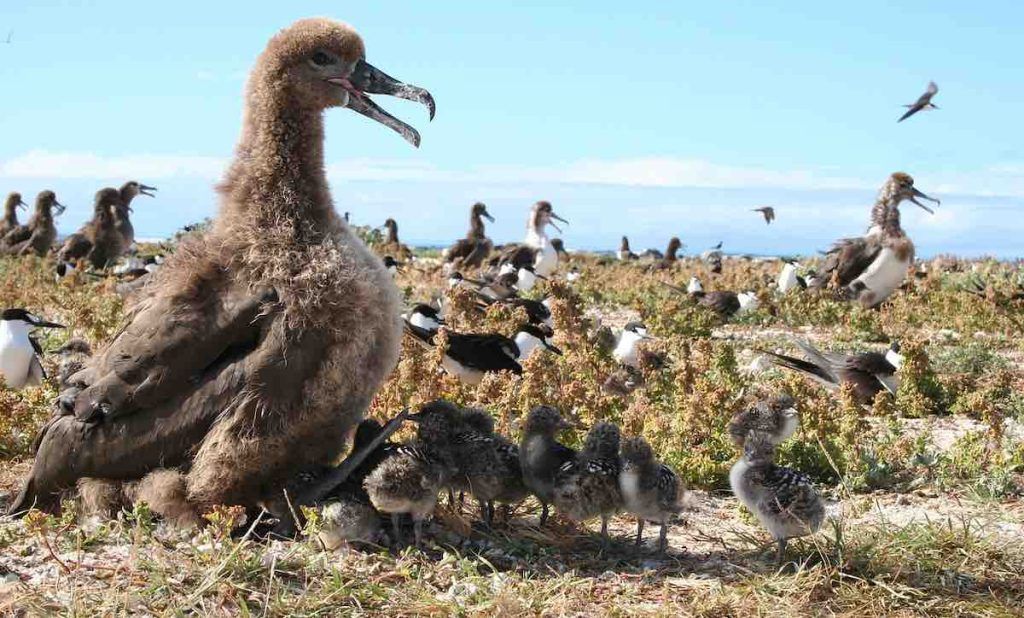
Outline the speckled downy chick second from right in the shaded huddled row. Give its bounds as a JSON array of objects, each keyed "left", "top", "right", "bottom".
[{"left": 554, "top": 423, "right": 623, "bottom": 543}]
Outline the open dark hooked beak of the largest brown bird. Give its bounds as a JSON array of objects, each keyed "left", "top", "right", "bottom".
[{"left": 328, "top": 59, "right": 436, "bottom": 147}]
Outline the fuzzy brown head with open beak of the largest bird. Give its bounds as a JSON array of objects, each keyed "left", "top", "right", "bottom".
[{"left": 249, "top": 18, "right": 434, "bottom": 146}]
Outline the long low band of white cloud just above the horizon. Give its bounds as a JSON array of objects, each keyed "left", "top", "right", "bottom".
[{"left": 6, "top": 150, "right": 1024, "bottom": 196}]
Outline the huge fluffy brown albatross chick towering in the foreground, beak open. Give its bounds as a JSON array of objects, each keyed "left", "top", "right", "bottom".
[{"left": 11, "top": 19, "right": 433, "bottom": 523}]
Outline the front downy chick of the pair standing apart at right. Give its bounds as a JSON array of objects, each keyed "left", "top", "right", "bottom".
[{"left": 729, "top": 432, "right": 825, "bottom": 565}]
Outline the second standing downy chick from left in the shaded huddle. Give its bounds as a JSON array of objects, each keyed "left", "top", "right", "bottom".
[{"left": 452, "top": 408, "right": 526, "bottom": 526}]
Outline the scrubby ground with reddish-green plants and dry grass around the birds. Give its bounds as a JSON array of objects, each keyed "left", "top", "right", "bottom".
[{"left": 0, "top": 247, "right": 1024, "bottom": 616}]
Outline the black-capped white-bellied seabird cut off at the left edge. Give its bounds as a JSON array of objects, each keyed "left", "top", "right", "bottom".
[{"left": 0, "top": 308, "right": 63, "bottom": 389}]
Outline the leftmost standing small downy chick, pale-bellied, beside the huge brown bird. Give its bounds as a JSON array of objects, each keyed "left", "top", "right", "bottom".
[{"left": 364, "top": 400, "right": 459, "bottom": 546}]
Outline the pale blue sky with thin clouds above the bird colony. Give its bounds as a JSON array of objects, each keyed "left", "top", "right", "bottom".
[{"left": 0, "top": 0, "right": 1024, "bottom": 257}]
